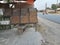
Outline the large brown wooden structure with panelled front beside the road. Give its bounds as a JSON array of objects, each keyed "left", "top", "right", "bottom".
[{"left": 0, "top": 2, "right": 38, "bottom": 30}]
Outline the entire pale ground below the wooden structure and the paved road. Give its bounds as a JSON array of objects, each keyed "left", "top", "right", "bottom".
[{"left": 0, "top": 17, "right": 60, "bottom": 45}]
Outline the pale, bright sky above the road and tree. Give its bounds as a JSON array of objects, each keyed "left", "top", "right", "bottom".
[{"left": 34, "top": 0, "right": 60, "bottom": 10}]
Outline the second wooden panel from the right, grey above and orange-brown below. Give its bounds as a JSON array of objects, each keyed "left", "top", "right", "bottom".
[{"left": 21, "top": 8, "right": 29, "bottom": 24}]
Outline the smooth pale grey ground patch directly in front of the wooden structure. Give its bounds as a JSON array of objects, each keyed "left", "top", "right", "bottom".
[{"left": 0, "top": 27, "right": 45, "bottom": 45}]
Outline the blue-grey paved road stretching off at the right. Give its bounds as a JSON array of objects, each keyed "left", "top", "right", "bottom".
[{"left": 38, "top": 13, "right": 60, "bottom": 24}]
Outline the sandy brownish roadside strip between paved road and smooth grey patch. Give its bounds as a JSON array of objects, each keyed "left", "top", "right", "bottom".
[{"left": 37, "top": 17, "right": 60, "bottom": 45}]
